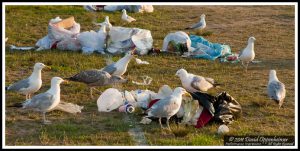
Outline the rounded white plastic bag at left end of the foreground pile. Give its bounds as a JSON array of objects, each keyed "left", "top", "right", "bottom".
[{"left": 97, "top": 88, "right": 124, "bottom": 112}]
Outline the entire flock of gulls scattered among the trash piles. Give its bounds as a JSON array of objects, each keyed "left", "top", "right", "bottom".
[{"left": 6, "top": 9, "right": 286, "bottom": 129}]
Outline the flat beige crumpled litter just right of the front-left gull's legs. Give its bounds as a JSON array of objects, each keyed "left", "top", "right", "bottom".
[{"left": 53, "top": 101, "right": 83, "bottom": 114}]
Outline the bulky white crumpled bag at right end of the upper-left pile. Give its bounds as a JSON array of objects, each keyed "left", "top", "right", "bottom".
[{"left": 106, "top": 27, "right": 153, "bottom": 55}]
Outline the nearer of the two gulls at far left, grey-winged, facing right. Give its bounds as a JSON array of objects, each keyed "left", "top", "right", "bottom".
[{"left": 9, "top": 77, "right": 67, "bottom": 124}]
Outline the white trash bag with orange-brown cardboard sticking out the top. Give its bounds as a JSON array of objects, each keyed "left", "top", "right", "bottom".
[{"left": 36, "top": 16, "right": 81, "bottom": 50}]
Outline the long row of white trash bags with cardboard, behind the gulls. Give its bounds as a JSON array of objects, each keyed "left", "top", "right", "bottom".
[{"left": 36, "top": 17, "right": 153, "bottom": 55}]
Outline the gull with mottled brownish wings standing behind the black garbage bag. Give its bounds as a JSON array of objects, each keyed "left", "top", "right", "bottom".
[{"left": 175, "top": 69, "right": 220, "bottom": 93}]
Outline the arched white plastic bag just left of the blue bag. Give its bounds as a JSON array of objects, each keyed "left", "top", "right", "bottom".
[{"left": 162, "top": 31, "right": 193, "bottom": 51}]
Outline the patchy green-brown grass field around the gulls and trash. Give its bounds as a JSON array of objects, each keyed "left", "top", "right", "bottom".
[{"left": 5, "top": 5, "right": 296, "bottom": 146}]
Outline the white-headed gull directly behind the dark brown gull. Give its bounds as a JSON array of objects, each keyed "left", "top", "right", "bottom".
[{"left": 100, "top": 48, "right": 135, "bottom": 76}]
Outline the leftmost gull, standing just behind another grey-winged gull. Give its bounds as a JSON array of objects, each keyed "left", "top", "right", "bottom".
[{"left": 5, "top": 63, "right": 51, "bottom": 99}]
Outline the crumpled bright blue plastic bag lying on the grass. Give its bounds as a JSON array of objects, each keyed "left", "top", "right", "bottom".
[{"left": 182, "top": 35, "right": 231, "bottom": 60}]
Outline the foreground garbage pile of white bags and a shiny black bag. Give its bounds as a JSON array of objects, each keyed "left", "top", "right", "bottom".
[{"left": 97, "top": 85, "right": 242, "bottom": 128}]
